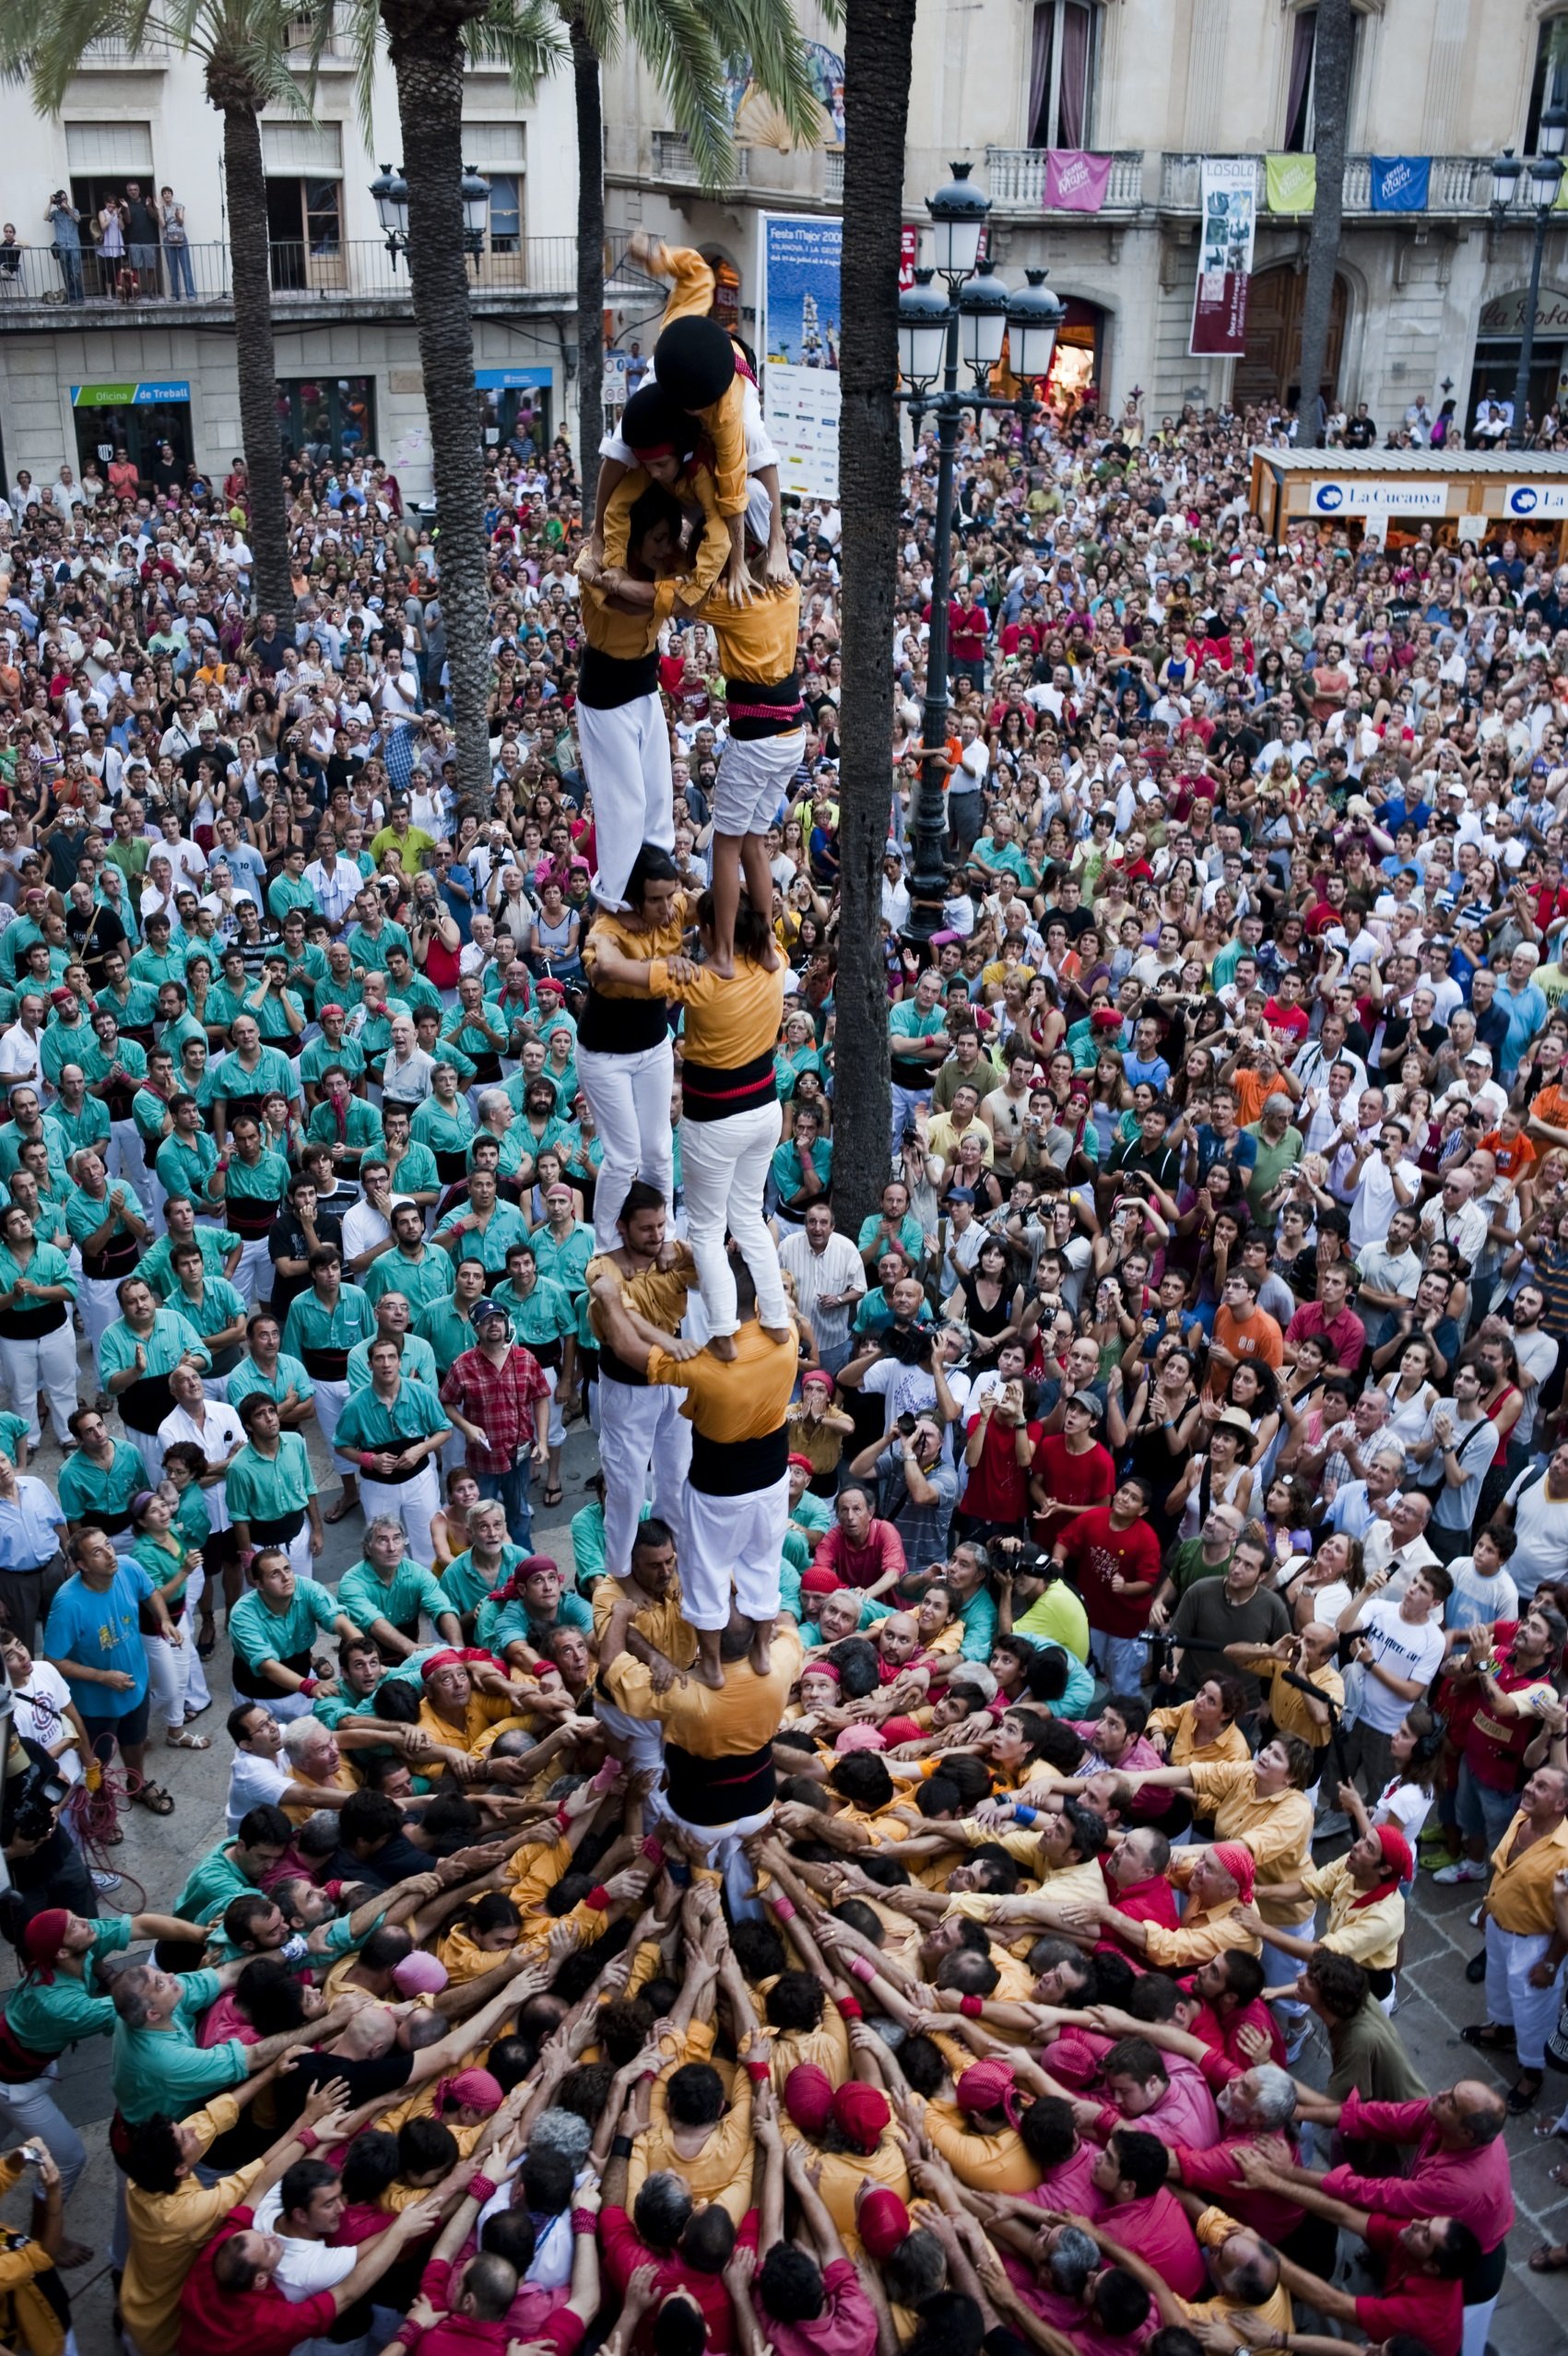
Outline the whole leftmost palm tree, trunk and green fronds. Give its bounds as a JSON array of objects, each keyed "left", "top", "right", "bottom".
[{"left": 0, "top": 0, "right": 312, "bottom": 619}]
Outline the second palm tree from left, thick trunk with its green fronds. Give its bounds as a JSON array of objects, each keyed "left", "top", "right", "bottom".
[{"left": 344, "top": 0, "right": 561, "bottom": 810}]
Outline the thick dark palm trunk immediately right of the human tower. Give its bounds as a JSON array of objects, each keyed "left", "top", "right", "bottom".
[{"left": 832, "top": 0, "right": 914, "bottom": 1234}]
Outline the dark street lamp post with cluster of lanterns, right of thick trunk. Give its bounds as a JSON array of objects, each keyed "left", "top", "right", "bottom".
[{"left": 896, "top": 162, "right": 1066, "bottom": 949}]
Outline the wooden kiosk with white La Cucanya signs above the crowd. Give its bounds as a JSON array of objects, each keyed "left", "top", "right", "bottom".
[{"left": 1250, "top": 448, "right": 1568, "bottom": 560}]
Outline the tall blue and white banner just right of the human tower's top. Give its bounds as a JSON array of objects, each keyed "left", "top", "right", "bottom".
[{"left": 757, "top": 212, "right": 844, "bottom": 500}]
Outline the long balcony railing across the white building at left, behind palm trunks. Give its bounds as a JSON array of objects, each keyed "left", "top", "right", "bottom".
[{"left": 0, "top": 236, "right": 632, "bottom": 332}]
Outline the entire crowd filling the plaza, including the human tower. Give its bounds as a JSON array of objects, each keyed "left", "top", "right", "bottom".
[{"left": 0, "top": 230, "right": 1568, "bottom": 2356}]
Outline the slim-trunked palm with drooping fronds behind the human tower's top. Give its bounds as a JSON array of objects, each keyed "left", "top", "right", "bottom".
[{"left": 559, "top": 0, "right": 837, "bottom": 512}]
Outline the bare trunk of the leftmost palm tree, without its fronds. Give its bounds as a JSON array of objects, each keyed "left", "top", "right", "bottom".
[{"left": 221, "top": 103, "right": 295, "bottom": 634}]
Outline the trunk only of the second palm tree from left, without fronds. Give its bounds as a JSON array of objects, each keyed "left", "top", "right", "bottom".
[{"left": 382, "top": 7, "right": 490, "bottom": 813}]
